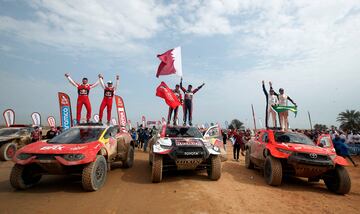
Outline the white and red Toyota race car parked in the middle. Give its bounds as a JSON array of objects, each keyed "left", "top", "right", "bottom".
[{"left": 149, "top": 125, "right": 221, "bottom": 183}]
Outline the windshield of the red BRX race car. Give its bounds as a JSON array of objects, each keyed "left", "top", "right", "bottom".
[{"left": 48, "top": 128, "right": 105, "bottom": 144}]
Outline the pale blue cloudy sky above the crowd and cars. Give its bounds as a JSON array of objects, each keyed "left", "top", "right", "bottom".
[{"left": 0, "top": 0, "right": 360, "bottom": 128}]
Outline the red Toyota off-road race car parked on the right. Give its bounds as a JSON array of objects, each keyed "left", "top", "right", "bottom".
[{"left": 245, "top": 129, "right": 351, "bottom": 194}]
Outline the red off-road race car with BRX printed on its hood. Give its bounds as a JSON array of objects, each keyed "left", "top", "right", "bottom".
[{"left": 10, "top": 124, "right": 134, "bottom": 191}]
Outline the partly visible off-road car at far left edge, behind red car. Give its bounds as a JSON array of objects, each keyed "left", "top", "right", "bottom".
[{"left": 0, "top": 125, "right": 33, "bottom": 161}]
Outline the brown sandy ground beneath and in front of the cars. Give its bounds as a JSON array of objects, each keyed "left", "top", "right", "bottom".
[{"left": 0, "top": 147, "right": 360, "bottom": 213}]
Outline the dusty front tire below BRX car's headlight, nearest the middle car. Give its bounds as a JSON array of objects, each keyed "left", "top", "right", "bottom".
[{"left": 82, "top": 155, "right": 107, "bottom": 191}]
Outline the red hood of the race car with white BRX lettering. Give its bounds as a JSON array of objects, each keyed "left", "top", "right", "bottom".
[{"left": 19, "top": 141, "right": 101, "bottom": 154}]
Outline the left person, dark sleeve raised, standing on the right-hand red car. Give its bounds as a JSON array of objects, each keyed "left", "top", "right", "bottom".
[{"left": 262, "top": 80, "right": 279, "bottom": 128}]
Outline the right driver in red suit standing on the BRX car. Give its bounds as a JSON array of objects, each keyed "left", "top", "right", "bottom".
[{"left": 99, "top": 74, "right": 119, "bottom": 125}]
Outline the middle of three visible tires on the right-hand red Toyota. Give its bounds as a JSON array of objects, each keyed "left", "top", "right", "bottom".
[{"left": 264, "top": 155, "right": 282, "bottom": 186}]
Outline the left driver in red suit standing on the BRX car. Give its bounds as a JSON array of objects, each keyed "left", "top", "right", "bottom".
[{"left": 65, "top": 74, "right": 99, "bottom": 123}]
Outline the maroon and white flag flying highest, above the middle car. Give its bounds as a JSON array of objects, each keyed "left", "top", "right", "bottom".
[{"left": 156, "top": 47, "right": 182, "bottom": 78}]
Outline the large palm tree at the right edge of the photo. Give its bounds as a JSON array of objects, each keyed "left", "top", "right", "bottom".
[{"left": 337, "top": 110, "right": 360, "bottom": 131}]
